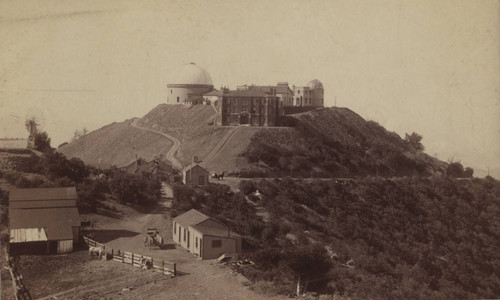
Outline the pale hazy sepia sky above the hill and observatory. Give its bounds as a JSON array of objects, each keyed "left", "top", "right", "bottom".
[{"left": 0, "top": 0, "right": 500, "bottom": 173}]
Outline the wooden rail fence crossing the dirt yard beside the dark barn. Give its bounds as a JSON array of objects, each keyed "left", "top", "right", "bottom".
[{"left": 83, "top": 237, "right": 177, "bottom": 276}]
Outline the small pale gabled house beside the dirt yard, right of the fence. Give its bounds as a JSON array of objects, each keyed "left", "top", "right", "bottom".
[{"left": 172, "top": 209, "right": 242, "bottom": 259}]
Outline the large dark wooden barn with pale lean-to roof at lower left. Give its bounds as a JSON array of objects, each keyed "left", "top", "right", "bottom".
[{"left": 9, "top": 187, "right": 80, "bottom": 254}]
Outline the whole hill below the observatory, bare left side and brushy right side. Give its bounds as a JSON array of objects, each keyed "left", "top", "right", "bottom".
[{"left": 59, "top": 104, "right": 446, "bottom": 177}]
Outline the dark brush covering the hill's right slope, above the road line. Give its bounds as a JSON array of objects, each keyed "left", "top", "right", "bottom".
[{"left": 243, "top": 108, "right": 445, "bottom": 177}]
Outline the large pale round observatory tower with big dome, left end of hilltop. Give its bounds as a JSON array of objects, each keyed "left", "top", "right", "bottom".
[{"left": 167, "top": 63, "right": 214, "bottom": 104}]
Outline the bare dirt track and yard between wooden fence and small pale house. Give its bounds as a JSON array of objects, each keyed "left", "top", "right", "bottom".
[{"left": 88, "top": 197, "right": 286, "bottom": 300}]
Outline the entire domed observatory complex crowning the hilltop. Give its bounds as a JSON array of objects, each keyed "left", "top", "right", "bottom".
[{"left": 167, "top": 63, "right": 324, "bottom": 126}]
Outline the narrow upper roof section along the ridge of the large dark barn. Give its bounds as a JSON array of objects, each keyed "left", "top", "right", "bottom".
[{"left": 9, "top": 187, "right": 78, "bottom": 201}]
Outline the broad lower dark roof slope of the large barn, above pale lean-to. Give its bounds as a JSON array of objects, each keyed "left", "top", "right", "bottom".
[{"left": 9, "top": 207, "right": 80, "bottom": 240}]
